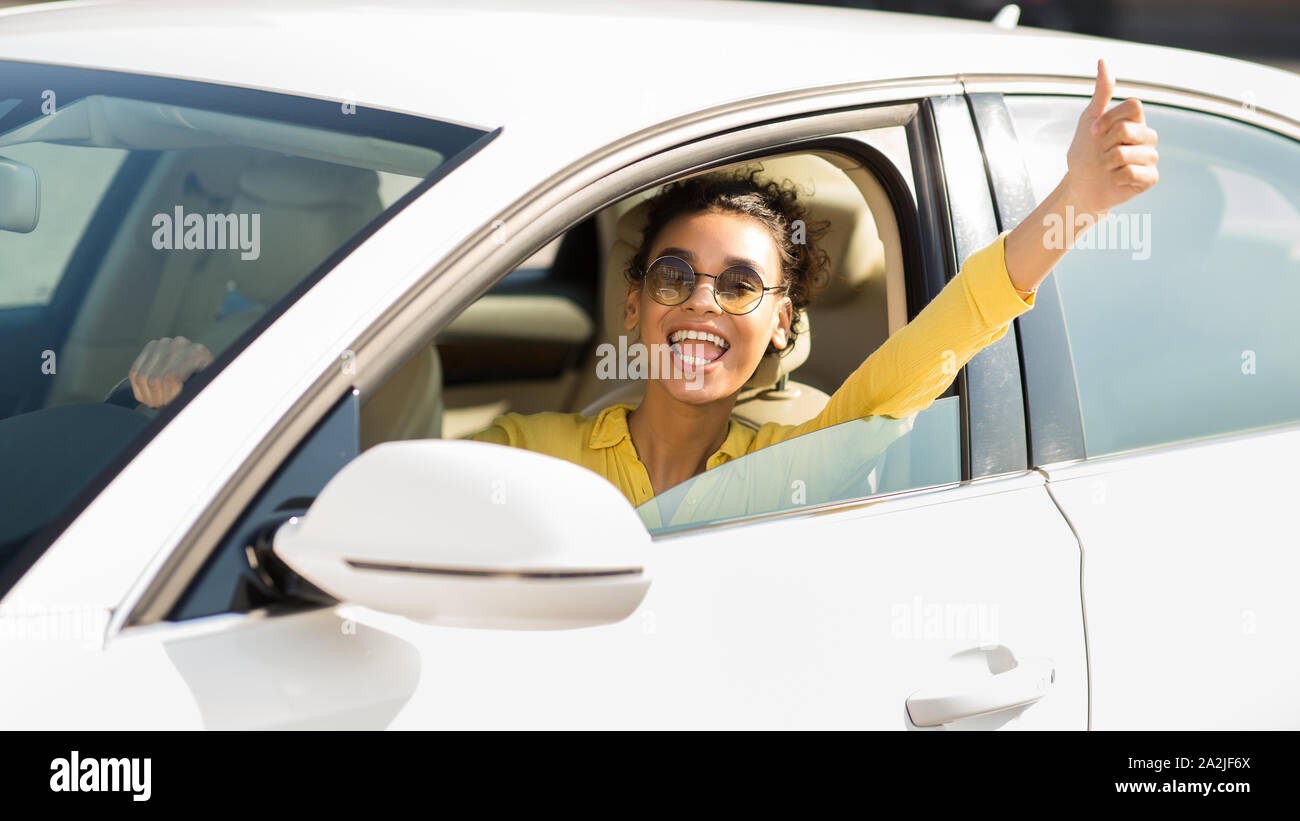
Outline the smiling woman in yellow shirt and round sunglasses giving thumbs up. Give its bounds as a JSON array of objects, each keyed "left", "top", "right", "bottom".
[{"left": 472, "top": 62, "right": 1156, "bottom": 505}]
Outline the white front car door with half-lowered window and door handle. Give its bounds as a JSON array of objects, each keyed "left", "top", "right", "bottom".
[{"left": 7, "top": 84, "right": 1087, "bottom": 729}]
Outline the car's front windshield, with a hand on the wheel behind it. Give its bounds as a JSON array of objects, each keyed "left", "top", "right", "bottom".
[{"left": 0, "top": 61, "right": 491, "bottom": 576}]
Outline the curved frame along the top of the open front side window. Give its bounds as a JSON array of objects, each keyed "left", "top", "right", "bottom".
[{"left": 109, "top": 77, "right": 1023, "bottom": 635}]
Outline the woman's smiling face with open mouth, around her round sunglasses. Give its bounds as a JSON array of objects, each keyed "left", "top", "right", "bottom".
[{"left": 624, "top": 210, "right": 792, "bottom": 404}]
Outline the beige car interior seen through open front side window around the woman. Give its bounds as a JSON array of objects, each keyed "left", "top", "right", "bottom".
[{"left": 361, "top": 151, "right": 906, "bottom": 459}]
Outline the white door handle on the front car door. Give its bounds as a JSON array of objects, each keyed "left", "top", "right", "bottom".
[{"left": 907, "top": 647, "right": 1056, "bottom": 727}]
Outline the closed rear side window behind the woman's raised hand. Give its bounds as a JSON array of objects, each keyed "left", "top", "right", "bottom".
[{"left": 1006, "top": 96, "right": 1300, "bottom": 456}]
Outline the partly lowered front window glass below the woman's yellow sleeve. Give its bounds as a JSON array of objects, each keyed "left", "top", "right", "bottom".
[{"left": 637, "top": 396, "right": 962, "bottom": 533}]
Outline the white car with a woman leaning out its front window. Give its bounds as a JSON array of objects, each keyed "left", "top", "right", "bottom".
[{"left": 0, "top": 0, "right": 1300, "bottom": 730}]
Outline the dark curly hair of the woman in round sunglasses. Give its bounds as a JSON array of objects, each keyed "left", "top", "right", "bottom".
[{"left": 624, "top": 164, "right": 831, "bottom": 355}]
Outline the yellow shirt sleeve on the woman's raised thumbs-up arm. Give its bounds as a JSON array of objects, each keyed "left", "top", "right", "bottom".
[{"left": 755, "top": 233, "right": 1034, "bottom": 448}]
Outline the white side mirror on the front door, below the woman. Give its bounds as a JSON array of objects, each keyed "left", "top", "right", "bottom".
[{"left": 273, "top": 439, "right": 650, "bottom": 630}]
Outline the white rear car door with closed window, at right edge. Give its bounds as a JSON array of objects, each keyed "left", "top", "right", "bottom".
[{"left": 974, "top": 83, "right": 1300, "bottom": 729}]
